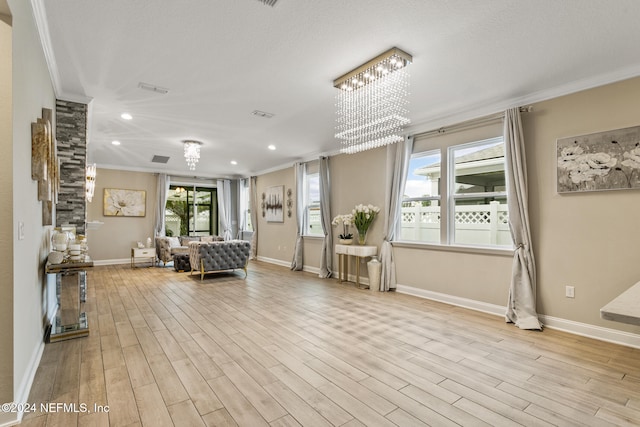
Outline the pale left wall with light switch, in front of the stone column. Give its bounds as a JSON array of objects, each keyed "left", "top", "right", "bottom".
[{"left": 7, "top": 0, "right": 55, "bottom": 418}]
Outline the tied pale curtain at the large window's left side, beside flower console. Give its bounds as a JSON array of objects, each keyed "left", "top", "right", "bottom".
[{"left": 379, "top": 136, "right": 413, "bottom": 291}]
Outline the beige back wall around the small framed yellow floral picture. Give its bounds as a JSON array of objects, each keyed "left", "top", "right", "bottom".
[{"left": 87, "top": 168, "right": 157, "bottom": 262}]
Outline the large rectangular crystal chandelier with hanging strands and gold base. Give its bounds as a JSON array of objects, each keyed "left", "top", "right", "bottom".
[{"left": 333, "top": 47, "right": 413, "bottom": 154}]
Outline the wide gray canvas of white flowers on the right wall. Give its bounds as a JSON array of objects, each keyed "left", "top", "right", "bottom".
[{"left": 557, "top": 126, "right": 640, "bottom": 193}]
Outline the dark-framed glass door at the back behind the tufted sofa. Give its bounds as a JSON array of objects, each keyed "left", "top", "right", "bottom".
[{"left": 165, "top": 185, "right": 218, "bottom": 236}]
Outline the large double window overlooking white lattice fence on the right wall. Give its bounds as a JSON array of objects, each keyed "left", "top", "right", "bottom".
[{"left": 400, "top": 137, "right": 513, "bottom": 248}]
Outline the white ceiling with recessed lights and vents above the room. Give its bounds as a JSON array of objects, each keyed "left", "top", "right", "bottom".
[{"left": 33, "top": 0, "right": 640, "bottom": 177}]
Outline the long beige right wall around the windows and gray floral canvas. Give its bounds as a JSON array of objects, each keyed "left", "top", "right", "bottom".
[{"left": 258, "top": 78, "right": 640, "bottom": 333}]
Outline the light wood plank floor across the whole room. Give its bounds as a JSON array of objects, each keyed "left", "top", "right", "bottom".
[{"left": 23, "top": 262, "right": 640, "bottom": 427}]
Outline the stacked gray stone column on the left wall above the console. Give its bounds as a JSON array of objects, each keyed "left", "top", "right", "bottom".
[{"left": 56, "top": 100, "right": 87, "bottom": 234}]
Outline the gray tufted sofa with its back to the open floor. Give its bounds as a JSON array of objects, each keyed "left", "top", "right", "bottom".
[{"left": 189, "top": 240, "right": 251, "bottom": 280}]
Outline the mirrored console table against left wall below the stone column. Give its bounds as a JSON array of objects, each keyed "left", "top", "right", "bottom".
[{"left": 45, "top": 256, "right": 93, "bottom": 342}]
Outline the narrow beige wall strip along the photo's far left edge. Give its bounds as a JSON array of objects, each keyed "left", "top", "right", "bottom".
[{"left": 0, "top": 5, "right": 14, "bottom": 412}]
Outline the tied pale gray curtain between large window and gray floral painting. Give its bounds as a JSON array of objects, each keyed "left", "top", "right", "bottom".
[{"left": 504, "top": 108, "right": 542, "bottom": 330}]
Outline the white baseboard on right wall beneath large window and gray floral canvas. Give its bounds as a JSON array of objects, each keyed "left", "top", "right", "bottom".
[{"left": 396, "top": 285, "right": 640, "bottom": 348}]
